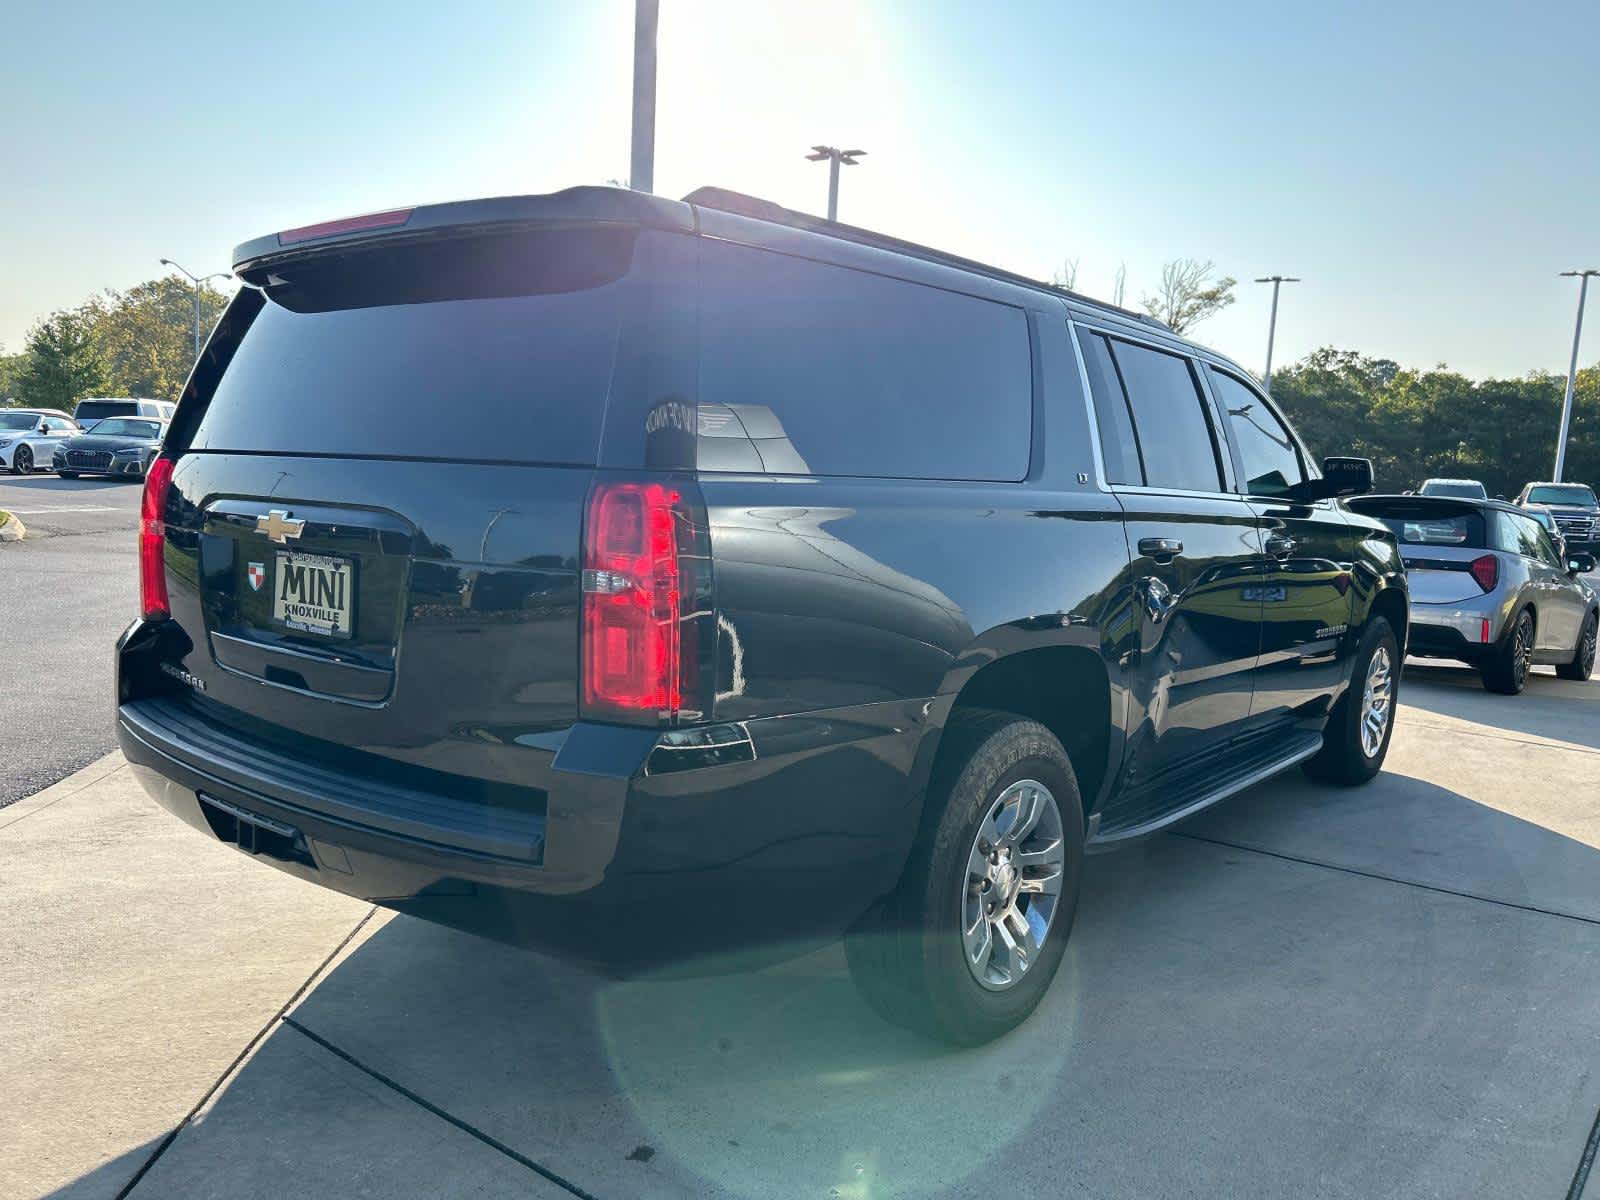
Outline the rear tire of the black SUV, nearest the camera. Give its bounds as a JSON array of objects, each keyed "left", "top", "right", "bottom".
[{"left": 845, "top": 709, "right": 1083, "bottom": 1046}]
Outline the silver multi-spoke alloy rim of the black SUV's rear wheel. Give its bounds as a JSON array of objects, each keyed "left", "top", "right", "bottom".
[{"left": 962, "top": 779, "right": 1066, "bottom": 992}]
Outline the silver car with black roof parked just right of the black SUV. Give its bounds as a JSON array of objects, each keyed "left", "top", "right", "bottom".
[{"left": 1350, "top": 496, "right": 1600, "bottom": 694}]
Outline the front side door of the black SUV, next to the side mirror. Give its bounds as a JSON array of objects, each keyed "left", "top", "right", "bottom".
[{"left": 1205, "top": 365, "right": 1356, "bottom": 722}]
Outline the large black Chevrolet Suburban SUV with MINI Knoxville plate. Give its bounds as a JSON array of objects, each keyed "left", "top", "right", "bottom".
[{"left": 117, "top": 187, "right": 1406, "bottom": 1042}]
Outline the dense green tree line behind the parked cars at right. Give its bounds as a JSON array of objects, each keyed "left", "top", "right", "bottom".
[{"left": 1272, "top": 349, "right": 1600, "bottom": 498}]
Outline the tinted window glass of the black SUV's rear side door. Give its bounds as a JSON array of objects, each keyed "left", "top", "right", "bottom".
[{"left": 1110, "top": 338, "right": 1222, "bottom": 491}]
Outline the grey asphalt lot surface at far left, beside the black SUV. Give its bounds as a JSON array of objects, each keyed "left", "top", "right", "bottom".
[{"left": 0, "top": 474, "right": 139, "bottom": 808}]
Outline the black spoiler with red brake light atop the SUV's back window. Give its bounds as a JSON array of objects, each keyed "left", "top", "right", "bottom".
[{"left": 234, "top": 187, "right": 694, "bottom": 282}]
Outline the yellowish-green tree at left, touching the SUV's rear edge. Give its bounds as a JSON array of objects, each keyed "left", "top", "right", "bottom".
[{"left": 94, "top": 275, "right": 227, "bottom": 400}]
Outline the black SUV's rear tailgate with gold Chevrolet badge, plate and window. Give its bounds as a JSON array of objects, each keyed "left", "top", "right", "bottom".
[{"left": 156, "top": 222, "right": 688, "bottom": 784}]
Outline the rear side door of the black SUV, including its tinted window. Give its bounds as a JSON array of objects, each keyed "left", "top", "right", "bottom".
[{"left": 1075, "top": 325, "right": 1262, "bottom": 786}]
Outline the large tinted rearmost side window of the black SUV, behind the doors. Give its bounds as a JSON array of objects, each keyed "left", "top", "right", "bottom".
[{"left": 699, "top": 242, "right": 1032, "bottom": 480}]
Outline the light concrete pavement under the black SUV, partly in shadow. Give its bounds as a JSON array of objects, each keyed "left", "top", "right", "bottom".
[{"left": 0, "top": 664, "right": 1600, "bottom": 1200}]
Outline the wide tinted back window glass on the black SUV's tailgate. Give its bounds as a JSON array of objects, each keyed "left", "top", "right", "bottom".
[{"left": 190, "top": 229, "right": 634, "bottom": 464}]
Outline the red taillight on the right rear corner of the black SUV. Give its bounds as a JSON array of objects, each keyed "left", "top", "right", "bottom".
[{"left": 582, "top": 483, "right": 683, "bottom": 720}]
